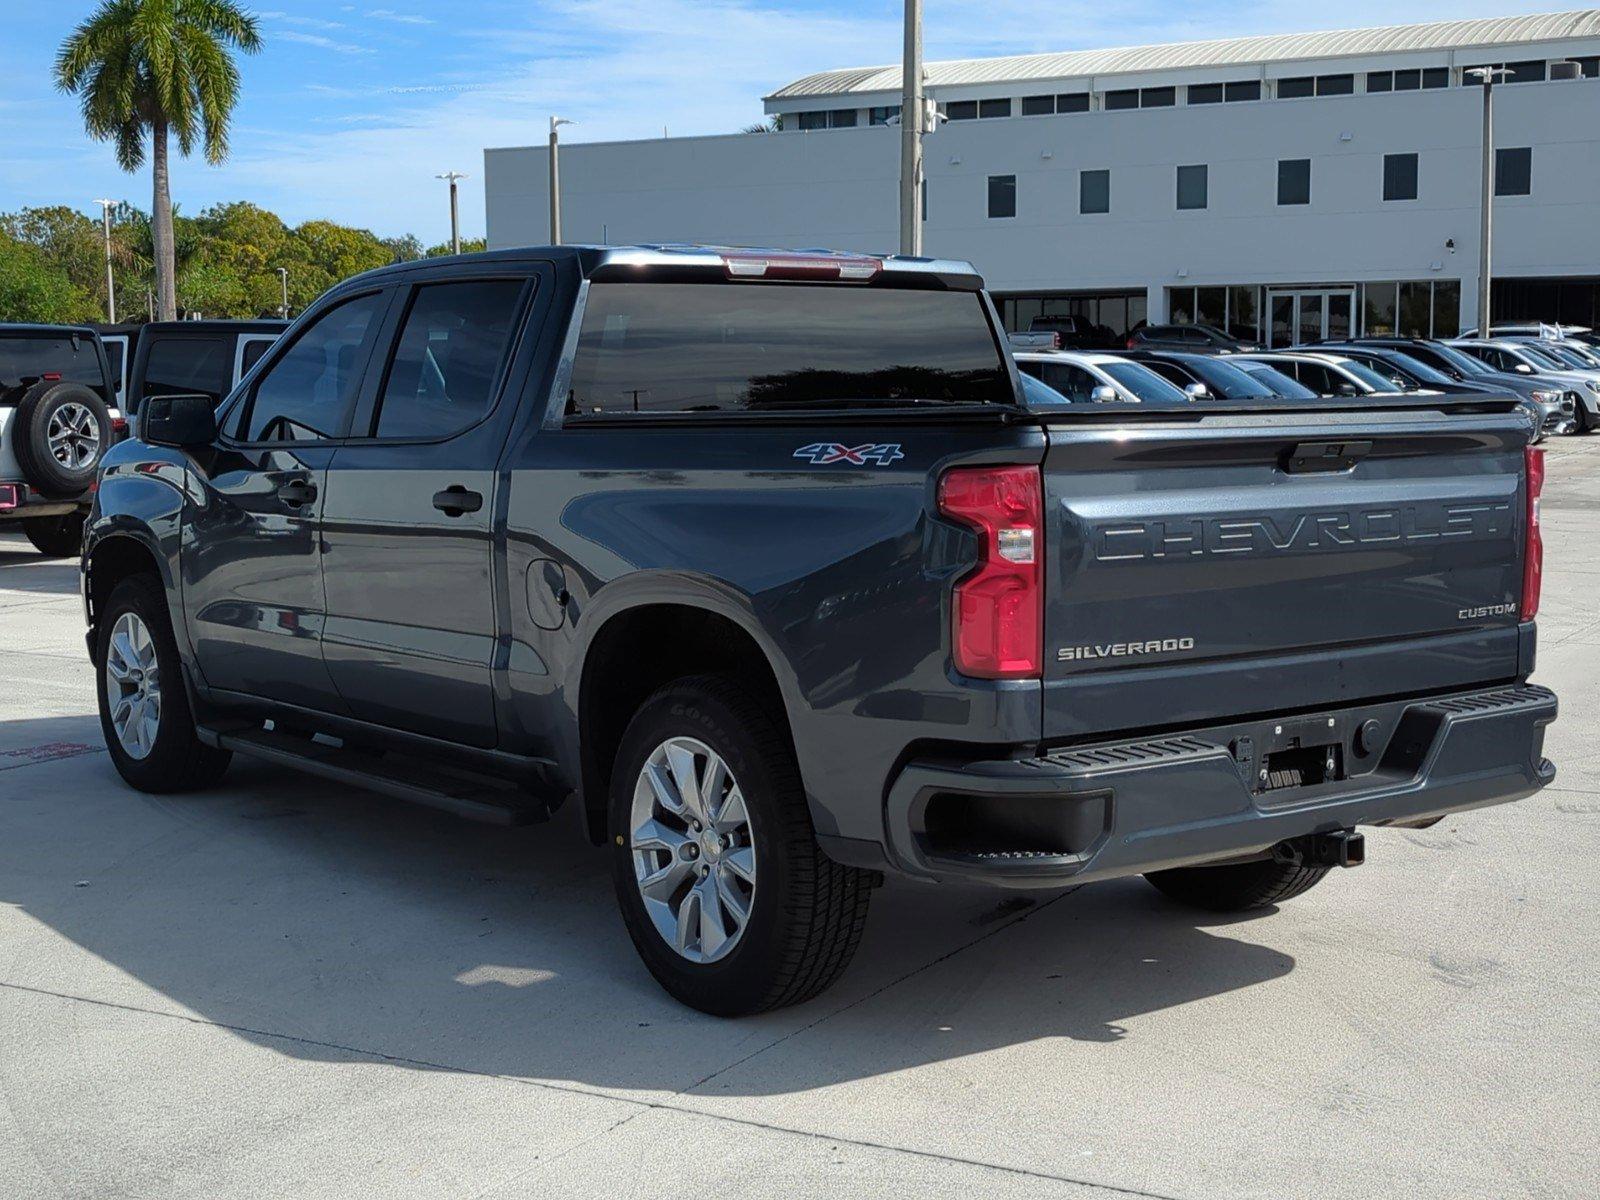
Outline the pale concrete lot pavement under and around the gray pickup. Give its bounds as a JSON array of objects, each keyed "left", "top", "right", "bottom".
[{"left": 0, "top": 438, "right": 1600, "bottom": 1200}]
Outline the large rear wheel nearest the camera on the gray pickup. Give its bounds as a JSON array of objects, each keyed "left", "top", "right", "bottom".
[{"left": 610, "top": 675, "right": 874, "bottom": 1016}]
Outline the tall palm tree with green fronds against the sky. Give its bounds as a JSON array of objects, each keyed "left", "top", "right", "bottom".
[{"left": 56, "top": 0, "right": 261, "bottom": 320}]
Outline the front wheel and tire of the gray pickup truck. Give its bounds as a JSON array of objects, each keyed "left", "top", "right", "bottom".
[{"left": 94, "top": 574, "right": 234, "bottom": 794}]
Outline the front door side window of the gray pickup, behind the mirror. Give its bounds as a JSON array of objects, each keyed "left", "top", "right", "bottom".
[{"left": 240, "top": 291, "right": 387, "bottom": 442}]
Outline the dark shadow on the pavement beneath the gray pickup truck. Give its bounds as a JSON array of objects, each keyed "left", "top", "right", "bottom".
[{"left": 0, "top": 715, "right": 1294, "bottom": 1094}]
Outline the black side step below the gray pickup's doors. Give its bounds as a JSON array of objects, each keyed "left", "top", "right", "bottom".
[{"left": 198, "top": 728, "right": 549, "bottom": 826}]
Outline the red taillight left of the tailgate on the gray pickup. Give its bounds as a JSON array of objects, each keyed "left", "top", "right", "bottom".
[{"left": 939, "top": 467, "right": 1045, "bottom": 678}]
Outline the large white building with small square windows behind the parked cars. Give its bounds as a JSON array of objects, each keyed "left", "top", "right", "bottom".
[{"left": 485, "top": 10, "right": 1600, "bottom": 342}]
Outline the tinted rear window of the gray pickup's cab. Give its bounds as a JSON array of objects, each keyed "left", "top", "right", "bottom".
[{"left": 566, "top": 283, "right": 1016, "bottom": 414}]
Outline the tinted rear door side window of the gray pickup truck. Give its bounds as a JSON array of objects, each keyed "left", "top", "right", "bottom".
[{"left": 373, "top": 280, "right": 523, "bottom": 437}]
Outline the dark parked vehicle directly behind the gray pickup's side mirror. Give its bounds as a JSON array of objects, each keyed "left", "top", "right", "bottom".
[{"left": 126, "top": 320, "right": 288, "bottom": 414}]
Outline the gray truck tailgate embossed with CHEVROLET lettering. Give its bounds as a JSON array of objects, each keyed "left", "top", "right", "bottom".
[{"left": 1043, "top": 410, "right": 1531, "bottom": 739}]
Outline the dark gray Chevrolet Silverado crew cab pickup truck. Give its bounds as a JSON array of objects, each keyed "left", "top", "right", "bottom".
[{"left": 83, "top": 246, "right": 1555, "bottom": 1014}]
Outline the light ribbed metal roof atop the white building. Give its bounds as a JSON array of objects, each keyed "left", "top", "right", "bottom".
[{"left": 765, "top": 8, "right": 1600, "bottom": 101}]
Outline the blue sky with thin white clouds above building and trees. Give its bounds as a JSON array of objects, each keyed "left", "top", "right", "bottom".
[{"left": 0, "top": 0, "right": 1560, "bottom": 242}]
